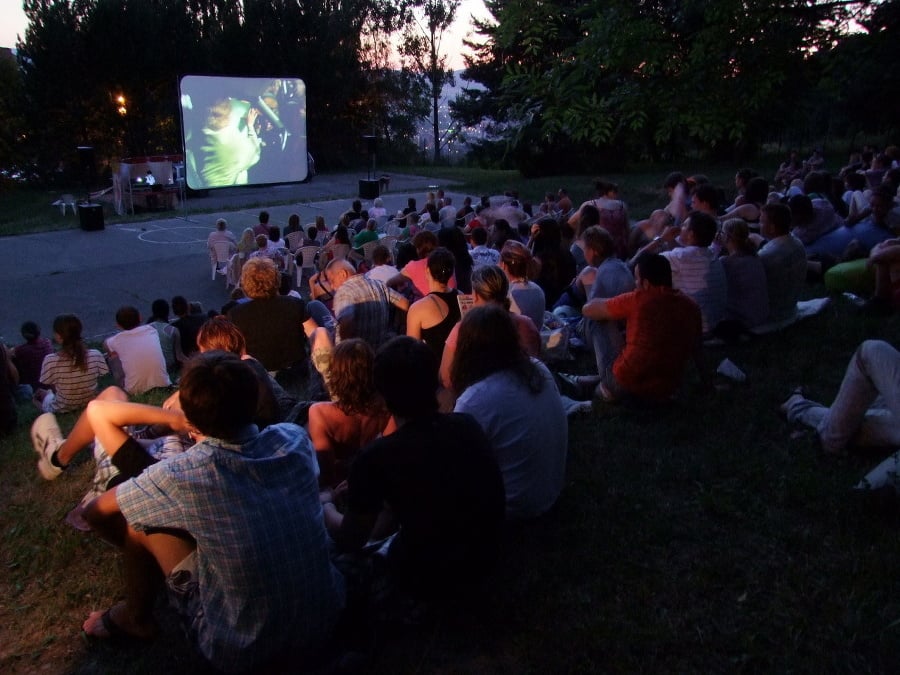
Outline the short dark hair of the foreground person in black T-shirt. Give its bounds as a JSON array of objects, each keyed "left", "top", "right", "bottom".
[{"left": 375, "top": 335, "right": 438, "bottom": 418}]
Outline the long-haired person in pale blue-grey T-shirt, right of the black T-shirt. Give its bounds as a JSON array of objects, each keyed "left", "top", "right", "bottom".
[{"left": 451, "top": 305, "right": 568, "bottom": 519}]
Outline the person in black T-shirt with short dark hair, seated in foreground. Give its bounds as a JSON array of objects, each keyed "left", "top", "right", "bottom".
[{"left": 322, "top": 336, "right": 505, "bottom": 603}]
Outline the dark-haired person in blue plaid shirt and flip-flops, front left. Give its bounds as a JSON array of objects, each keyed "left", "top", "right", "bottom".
[{"left": 83, "top": 352, "right": 344, "bottom": 672}]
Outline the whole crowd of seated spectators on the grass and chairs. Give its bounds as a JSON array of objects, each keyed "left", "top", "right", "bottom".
[{"left": 10, "top": 160, "right": 900, "bottom": 671}]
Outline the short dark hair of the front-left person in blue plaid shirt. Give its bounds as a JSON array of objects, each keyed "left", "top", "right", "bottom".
[{"left": 179, "top": 350, "right": 259, "bottom": 440}]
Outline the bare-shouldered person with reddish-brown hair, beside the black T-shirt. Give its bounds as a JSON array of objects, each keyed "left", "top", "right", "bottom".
[{"left": 306, "top": 338, "right": 390, "bottom": 487}]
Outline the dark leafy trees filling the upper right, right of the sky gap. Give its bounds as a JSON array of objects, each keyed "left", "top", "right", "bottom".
[{"left": 453, "top": 0, "right": 900, "bottom": 172}]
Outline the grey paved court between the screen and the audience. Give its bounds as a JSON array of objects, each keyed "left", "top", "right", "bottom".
[{"left": 0, "top": 174, "right": 465, "bottom": 344}]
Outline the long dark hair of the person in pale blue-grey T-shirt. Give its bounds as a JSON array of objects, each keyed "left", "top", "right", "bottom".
[{"left": 450, "top": 305, "right": 544, "bottom": 396}]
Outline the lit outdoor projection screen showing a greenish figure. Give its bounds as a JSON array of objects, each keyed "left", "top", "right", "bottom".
[{"left": 180, "top": 75, "right": 307, "bottom": 190}]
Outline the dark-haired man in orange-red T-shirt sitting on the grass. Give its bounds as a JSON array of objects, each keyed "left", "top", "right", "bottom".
[{"left": 582, "top": 253, "right": 704, "bottom": 402}]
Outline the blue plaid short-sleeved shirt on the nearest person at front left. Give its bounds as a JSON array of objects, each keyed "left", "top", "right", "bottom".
[{"left": 116, "top": 424, "right": 344, "bottom": 672}]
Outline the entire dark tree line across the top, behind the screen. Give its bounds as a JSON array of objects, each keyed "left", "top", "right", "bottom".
[{"left": 7, "top": 0, "right": 900, "bottom": 182}]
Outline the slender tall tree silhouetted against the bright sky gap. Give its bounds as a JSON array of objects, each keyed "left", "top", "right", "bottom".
[{"left": 400, "top": 0, "right": 460, "bottom": 163}]
